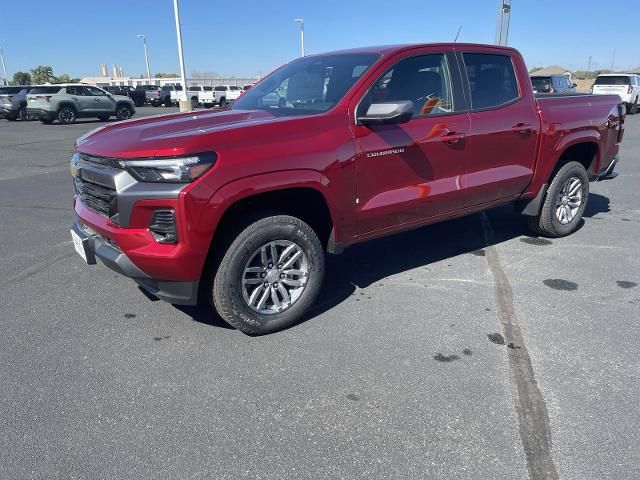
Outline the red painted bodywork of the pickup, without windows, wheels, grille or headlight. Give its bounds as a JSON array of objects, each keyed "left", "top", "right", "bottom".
[{"left": 75, "top": 44, "right": 620, "bottom": 281}]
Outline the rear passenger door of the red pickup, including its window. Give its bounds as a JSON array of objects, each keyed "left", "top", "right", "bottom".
[{"left": 458, "top": 47, "right": 540, "bottom": 205}]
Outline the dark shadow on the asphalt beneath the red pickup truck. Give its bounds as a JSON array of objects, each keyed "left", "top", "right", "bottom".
[{"left": 175, "top": 193, "right": 610, "bottom": 329}]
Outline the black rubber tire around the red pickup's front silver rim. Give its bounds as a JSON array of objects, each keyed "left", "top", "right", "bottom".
[{"left": 210, "top": 214, "right": 324, "bottom": 335}]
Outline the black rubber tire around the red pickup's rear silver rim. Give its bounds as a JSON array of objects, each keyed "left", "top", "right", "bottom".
[{"left": 529, "top": 162, "right": 589, "bottom": 237}]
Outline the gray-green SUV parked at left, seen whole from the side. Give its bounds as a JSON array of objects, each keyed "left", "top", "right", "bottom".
[{"left": 27, "top": 84, "right": 136, "bottom": 124}]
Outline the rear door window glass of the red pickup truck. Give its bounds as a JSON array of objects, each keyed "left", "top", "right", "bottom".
[{"left": 463, "top": 53, "right": 518, "bottom": 109}]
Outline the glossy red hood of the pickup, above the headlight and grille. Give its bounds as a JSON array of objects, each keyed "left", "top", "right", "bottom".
[{"left": 76, "top": 110, "right": 280, "bottom": 158}]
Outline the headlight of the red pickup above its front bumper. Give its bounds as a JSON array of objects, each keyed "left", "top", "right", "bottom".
[{"left": 118, "top": 153, "right": 216, "bottom": 183}]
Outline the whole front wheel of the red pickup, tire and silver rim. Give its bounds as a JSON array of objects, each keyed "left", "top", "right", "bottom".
[{"left": 211, "top": 215, "right": 324, "bottom": 335}]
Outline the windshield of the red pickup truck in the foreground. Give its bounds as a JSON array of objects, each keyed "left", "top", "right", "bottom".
[{"left": 231, "top": 53, "right": 379, "bottom": 116}]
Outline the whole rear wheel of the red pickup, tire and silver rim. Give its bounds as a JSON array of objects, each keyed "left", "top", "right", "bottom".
[{"left": 529, "top": 162, "right": 589, "bottom": 237}]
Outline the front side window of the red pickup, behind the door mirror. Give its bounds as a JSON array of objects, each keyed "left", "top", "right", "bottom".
[{"left": 358, "top": 53, "right": 453, "bottom": 118}]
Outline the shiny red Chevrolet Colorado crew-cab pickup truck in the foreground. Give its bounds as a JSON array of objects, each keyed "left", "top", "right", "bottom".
[{"left": 71, "top": 43, "right": 624, "bottom": 334}]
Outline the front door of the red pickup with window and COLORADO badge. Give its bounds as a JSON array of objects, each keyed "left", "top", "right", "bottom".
[{"left": 354, "top": 48, "right": 469, "bottom": 237}]
